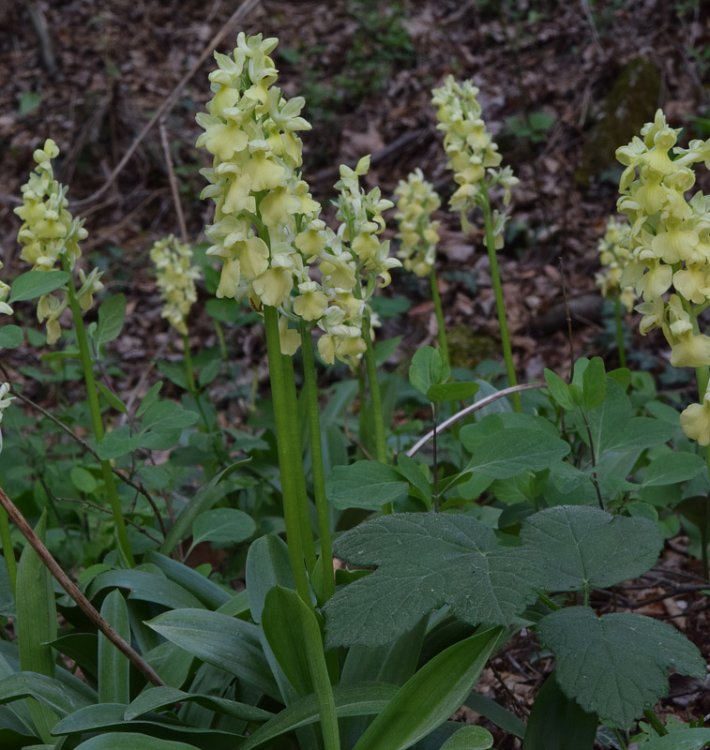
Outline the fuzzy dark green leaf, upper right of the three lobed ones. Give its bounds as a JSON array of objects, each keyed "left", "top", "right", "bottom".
[{"left": 521, "top": 505, "right": 663, "bottom": 591}]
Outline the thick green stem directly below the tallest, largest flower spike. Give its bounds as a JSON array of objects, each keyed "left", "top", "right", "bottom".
[{"left": 264, "top": 306, "right": 311, "bottom": 607}]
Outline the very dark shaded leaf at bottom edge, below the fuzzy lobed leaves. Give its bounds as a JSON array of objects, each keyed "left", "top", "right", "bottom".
[{"left": 523, "top": 674, "right": 599, "bottom": 750}]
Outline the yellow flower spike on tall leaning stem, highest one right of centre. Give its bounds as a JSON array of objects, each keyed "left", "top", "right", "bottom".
[{"left": 432, "top": 76, "right": 518, "bottom": 232}]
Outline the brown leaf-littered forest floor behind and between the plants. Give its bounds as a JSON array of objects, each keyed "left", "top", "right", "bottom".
[{"left": 0, "top": 0, "right": 710, "bottom": 750}]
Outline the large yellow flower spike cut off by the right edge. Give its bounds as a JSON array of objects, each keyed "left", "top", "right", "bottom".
[{"left": 616, "top": 109, "right": 710, "bottom": 445}]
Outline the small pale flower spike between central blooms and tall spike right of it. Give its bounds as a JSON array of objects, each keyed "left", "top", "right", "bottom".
[{"left": 395, "top": 168, "right": 441, "bottom": 277}]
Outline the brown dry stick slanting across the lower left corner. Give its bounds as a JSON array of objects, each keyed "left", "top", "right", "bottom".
[{"left": 0, "top": 487, "right": 165, "bottom": 687}]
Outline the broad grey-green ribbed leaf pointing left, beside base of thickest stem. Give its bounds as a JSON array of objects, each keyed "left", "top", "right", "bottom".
[{"left": 148, "top": 609, "right": 280, "bottom": 700}]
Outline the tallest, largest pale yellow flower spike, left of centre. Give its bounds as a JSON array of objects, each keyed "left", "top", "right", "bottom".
[{"left": 197, "top": 33, "right": 320, "bottom": 324}]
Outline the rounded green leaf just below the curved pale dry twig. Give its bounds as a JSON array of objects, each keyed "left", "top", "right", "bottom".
[{"left": 461, "top": 414, "right": 570, "bottom": 479}]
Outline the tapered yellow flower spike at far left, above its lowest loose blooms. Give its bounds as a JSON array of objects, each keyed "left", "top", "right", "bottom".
[{"left": 15, "top": 139, "right": 87, "bottom": 271}]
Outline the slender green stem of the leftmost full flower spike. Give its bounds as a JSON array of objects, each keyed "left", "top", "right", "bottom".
[{"left": 63, "top": 262, "right": 135, "bottom": 567}]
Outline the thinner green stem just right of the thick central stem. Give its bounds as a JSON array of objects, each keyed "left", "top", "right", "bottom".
[{"left": 301, "top": 322, "right": 335, "bottom": 601}]
